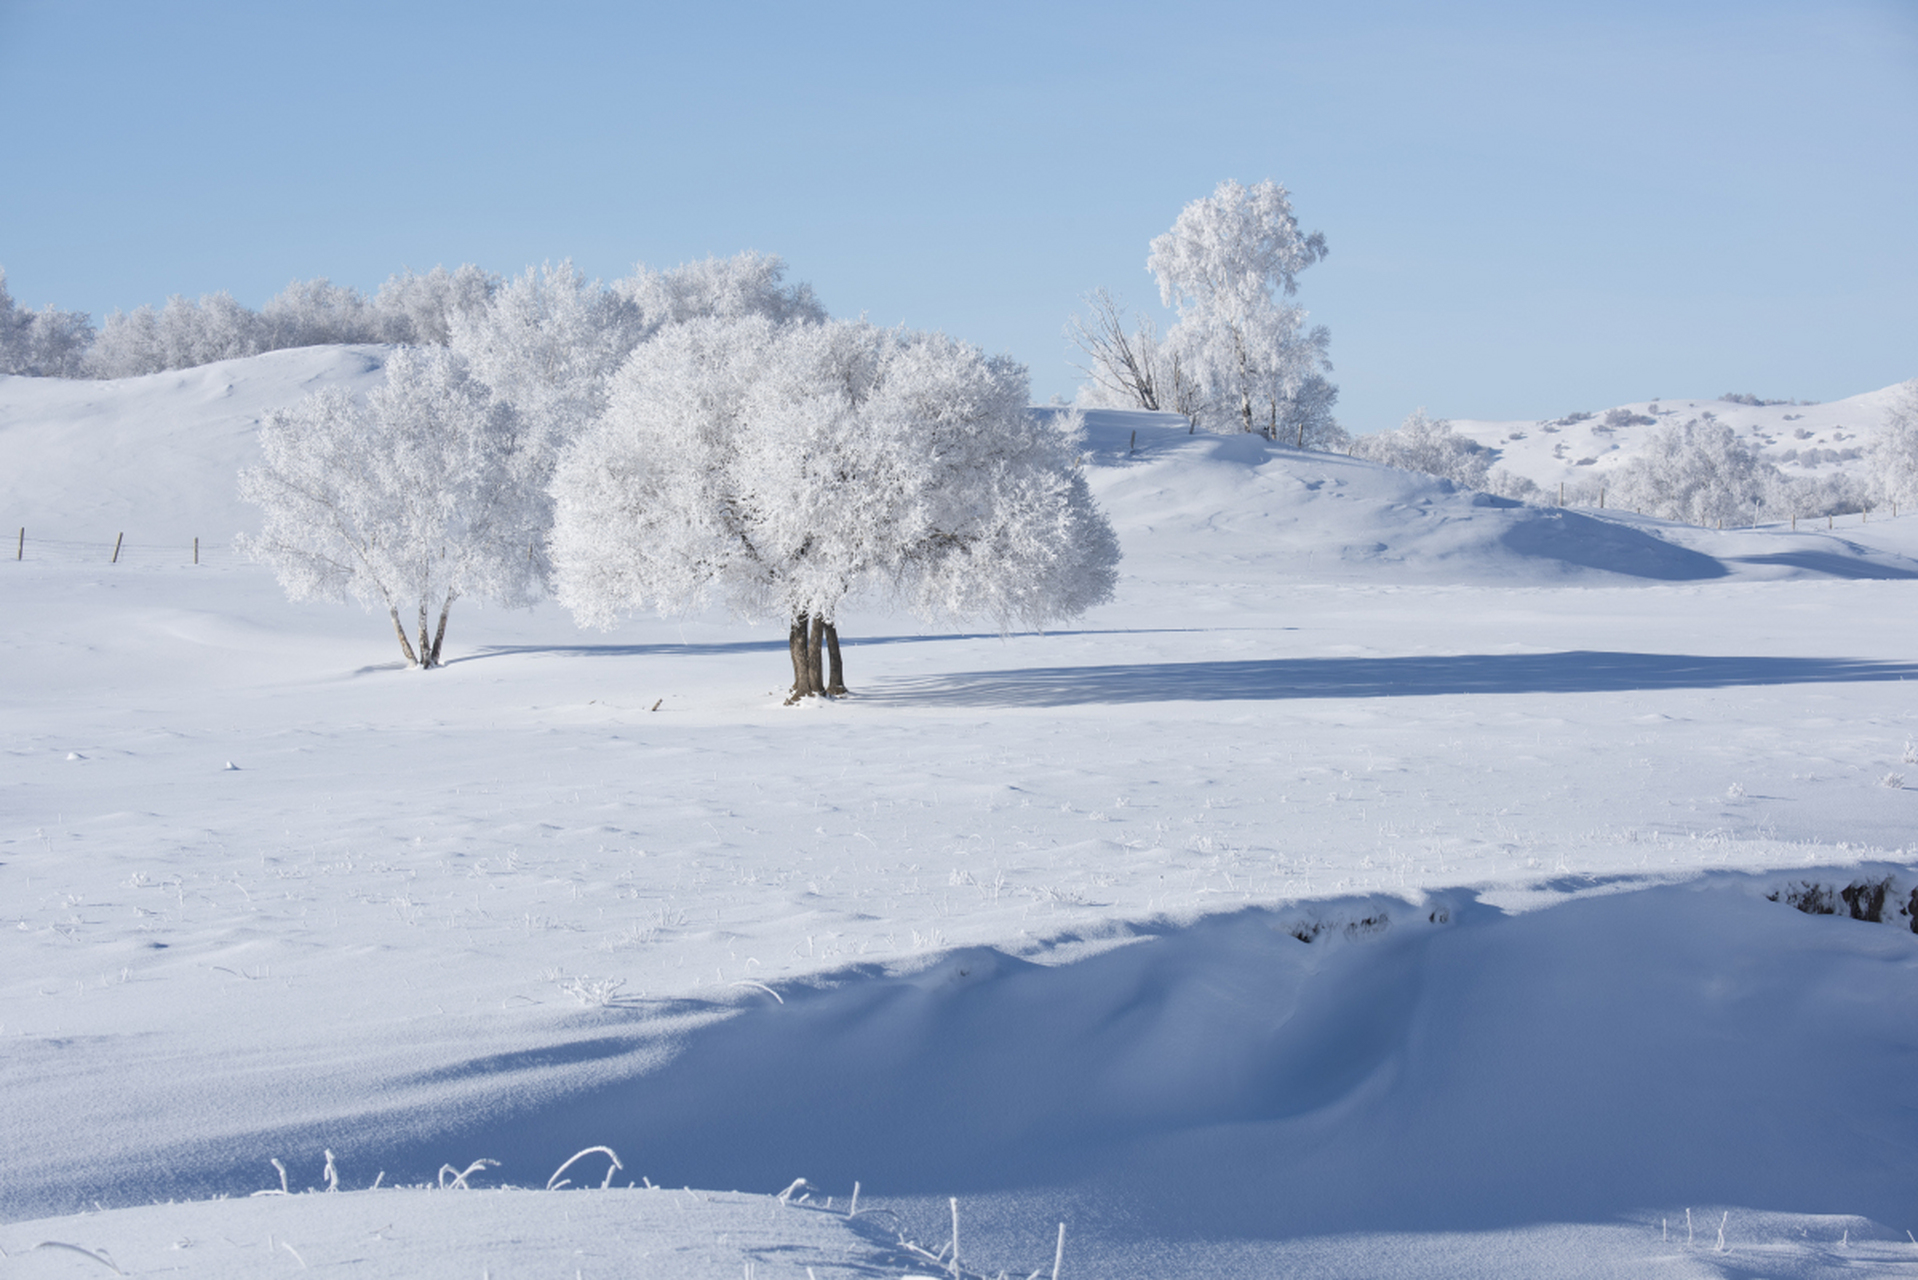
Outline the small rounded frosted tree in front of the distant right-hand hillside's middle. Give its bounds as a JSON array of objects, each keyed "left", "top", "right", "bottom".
[{"left": 1611, "top": 415, "right": 1786, "bottom": 524}]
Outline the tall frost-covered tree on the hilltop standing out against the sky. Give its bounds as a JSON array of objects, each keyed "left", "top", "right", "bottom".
[{"left": 1147, "top": 180, "right": 1337, "bottom": 445}]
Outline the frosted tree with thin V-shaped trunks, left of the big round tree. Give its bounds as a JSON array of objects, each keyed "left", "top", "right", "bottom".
[{"left": 240, "top": 347, "right": 547, "bottom": 668}]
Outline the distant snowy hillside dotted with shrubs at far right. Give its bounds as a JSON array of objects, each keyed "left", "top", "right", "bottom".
[{"left": 1452, "top": 384, "right": 1901, "bottom": 493}]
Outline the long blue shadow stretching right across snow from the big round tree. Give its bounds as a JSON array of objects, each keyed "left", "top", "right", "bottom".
[{"left": 861, "top": 651, "right": 1918, "bottom": 706}]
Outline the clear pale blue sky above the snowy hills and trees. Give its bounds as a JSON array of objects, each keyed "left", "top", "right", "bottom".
[{"left": 0, "top": 0, "right": 1918, "bottom": 432}]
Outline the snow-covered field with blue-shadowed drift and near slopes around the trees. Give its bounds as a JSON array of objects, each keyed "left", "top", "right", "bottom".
[{"left": 0, "top": 347, "right": 1918, "bottom": 1280}]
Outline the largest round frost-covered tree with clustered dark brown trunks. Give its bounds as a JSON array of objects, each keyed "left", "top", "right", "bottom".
[{"left": 554, "top": 315, "right": 1118, "bottom": 700}]
